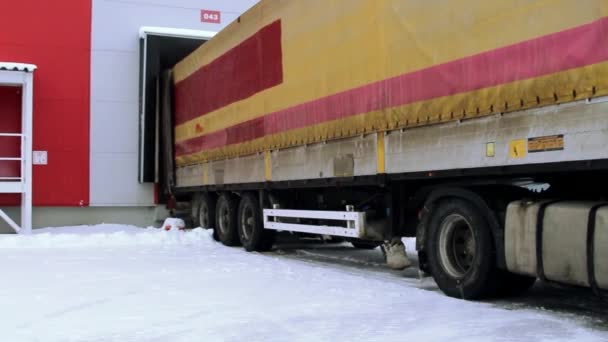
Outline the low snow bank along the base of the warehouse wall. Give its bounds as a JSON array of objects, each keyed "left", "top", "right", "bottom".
[{"left": 0, "top": 224, "right": 213, "bottom": 249}]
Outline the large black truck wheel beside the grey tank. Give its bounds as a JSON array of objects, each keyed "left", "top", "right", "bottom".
[{"left": 426, "top": 199, "right": 496, "bottom": 299}]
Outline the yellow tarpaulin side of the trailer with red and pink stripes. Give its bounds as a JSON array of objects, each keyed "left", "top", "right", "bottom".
[{"left": 174, "top": 0, "right": 608, "bottom": 166}]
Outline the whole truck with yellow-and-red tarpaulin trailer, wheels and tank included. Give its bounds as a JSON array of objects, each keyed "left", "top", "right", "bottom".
[{"left": 162, "top": 0, "right": 608, "bottom": 298}]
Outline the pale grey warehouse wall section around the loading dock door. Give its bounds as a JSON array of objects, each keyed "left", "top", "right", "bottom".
[{"left": 90, "top": 0, "right": 257, "bottom": 206}]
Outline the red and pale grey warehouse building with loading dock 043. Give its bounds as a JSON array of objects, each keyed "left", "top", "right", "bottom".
[{"left": 0, "top": 0, "right": 257, "bottom": 232}]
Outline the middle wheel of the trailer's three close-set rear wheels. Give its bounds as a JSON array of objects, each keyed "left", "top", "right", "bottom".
[{"left": 214, "top": 193, "right": 240, "bottom": 246}]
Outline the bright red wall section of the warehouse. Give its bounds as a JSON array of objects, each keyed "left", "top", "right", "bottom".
[{"left": 0, "top": 0, "right": 91, "bottom": 206}]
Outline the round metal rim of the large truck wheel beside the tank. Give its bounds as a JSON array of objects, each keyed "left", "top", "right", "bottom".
[{"left": 439, "top": 214, "right": 477, "bottom": 279}]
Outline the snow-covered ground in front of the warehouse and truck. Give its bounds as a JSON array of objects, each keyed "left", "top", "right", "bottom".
[{"left": 0, "top": 225, "right": 608, "bottom": 342}]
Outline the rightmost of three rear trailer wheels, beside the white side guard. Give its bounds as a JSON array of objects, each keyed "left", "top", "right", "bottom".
[{"left": 238, "top": 193, "right": 275, "bottom": 252}]
